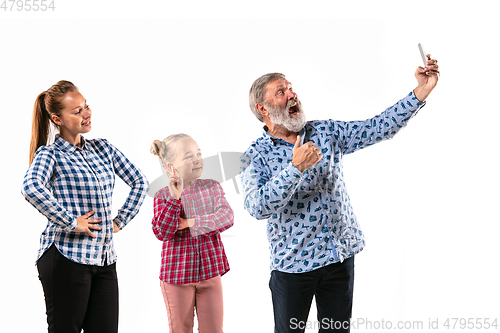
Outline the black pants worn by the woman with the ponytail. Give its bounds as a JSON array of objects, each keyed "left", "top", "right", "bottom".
[{"left": 37, "top": 245, "right": 118, "bottom": 333}]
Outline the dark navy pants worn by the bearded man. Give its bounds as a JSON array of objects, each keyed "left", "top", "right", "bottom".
[{"left": 269, "top": 257, "right": 354, "bottom": 333}]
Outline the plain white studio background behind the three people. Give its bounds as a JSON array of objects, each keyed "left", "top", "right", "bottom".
[{"left": 0, "top": 0, "right": 500, "bottom": 333}]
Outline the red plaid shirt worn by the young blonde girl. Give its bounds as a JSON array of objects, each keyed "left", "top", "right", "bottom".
[{"left": 152, "top": 179, "right": 233, "bottom": 284}]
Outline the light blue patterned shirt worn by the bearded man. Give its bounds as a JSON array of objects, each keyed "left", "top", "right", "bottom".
[{"left": 240, "top": 92, "right": 425, "bottom": 273}]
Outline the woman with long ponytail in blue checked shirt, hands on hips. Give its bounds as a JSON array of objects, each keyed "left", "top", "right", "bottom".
[{"left": 22, "top": 81, "right": 148, "bottom": 333}]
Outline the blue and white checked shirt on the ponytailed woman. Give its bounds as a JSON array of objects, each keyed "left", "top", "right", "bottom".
[{"left": 22, "top": 136, "right": 149, "bottom": 266}]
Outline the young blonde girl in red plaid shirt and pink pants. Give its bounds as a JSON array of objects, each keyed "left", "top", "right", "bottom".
[{"left": 151, "top": 134, "right": 233, "bottom": 333}]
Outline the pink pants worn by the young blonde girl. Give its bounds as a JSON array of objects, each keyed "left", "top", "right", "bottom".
[{"left": 160, "top": 276, "right": 223, "bottom": 333}]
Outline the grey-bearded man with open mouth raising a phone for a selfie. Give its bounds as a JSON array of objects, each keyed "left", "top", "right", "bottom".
[{"left": 241, "top": 56, "right": 439, "bottom": 333}]
